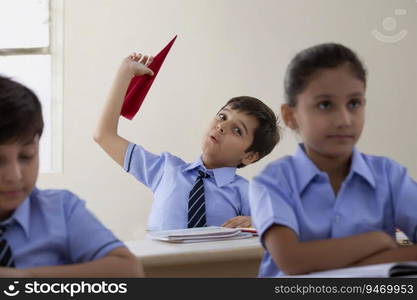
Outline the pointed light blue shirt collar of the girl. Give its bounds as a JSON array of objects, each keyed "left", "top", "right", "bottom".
[{"left": 294, "top": 144, "right": 375, "bottom": 193}]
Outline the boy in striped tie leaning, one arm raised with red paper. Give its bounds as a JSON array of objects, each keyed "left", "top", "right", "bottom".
[{"left": 95, "top": 54, "right": 279, "bottom": 230}]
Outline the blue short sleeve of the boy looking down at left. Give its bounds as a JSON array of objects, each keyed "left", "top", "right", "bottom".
[{"left": 65, "top": 193, "right": 125, "bottom": 263}]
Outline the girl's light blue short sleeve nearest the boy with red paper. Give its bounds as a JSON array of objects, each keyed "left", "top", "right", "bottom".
[{"left": 249, "top": 164, "right": 299, "bottom": 243}]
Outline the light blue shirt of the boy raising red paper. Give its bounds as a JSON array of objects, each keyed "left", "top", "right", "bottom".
[{"left": 124, "top": 144, "right": 250, "bottom": 230}]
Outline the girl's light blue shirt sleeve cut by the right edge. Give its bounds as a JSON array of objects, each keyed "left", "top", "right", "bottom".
[{"left": 388, "top": 162, "right": 417, "bottom": 243}]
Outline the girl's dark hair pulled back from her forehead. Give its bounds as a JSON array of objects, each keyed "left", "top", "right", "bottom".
[{"left": 284, "top": 43, "right": 366, "bottom": 107}]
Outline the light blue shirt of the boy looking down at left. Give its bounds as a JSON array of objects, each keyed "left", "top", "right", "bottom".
[{"left": 2, "top": 188, "right": 124, "bottom": 268}]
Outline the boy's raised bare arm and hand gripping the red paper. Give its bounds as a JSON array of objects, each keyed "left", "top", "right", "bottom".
[{"left": 94, "top": 53, "right": 153, "bottom": 167}]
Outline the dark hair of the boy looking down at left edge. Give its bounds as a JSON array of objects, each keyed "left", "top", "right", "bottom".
[{"left": 0, "top": 75, "right": 43, "bottom": 144}]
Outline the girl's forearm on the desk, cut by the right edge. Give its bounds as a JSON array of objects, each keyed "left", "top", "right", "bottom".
[{"left": 354, "top": 245, "right": 417, "bottom": 266}]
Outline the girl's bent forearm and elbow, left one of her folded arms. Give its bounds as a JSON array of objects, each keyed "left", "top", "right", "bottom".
[{"left": 264, "top": 225, "right": 398, "bottom": 275}]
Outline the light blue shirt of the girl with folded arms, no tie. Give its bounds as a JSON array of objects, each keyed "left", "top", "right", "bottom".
[{"left": 249, "top": 145, "right": 417, "bottom": 277}]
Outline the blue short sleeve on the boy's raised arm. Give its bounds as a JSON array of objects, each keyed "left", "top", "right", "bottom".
[{"left": 124, "top": 143, "right": 168, "bottom": 191}]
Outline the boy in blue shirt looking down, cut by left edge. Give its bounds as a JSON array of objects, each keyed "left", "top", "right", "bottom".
[{"left": 0, "top": 76, "right": 143, "bottom": 277}]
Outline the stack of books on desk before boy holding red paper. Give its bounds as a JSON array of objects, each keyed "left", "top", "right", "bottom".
[{"left": 149, "top": 226, "right": 256, "bottom": 243}]
